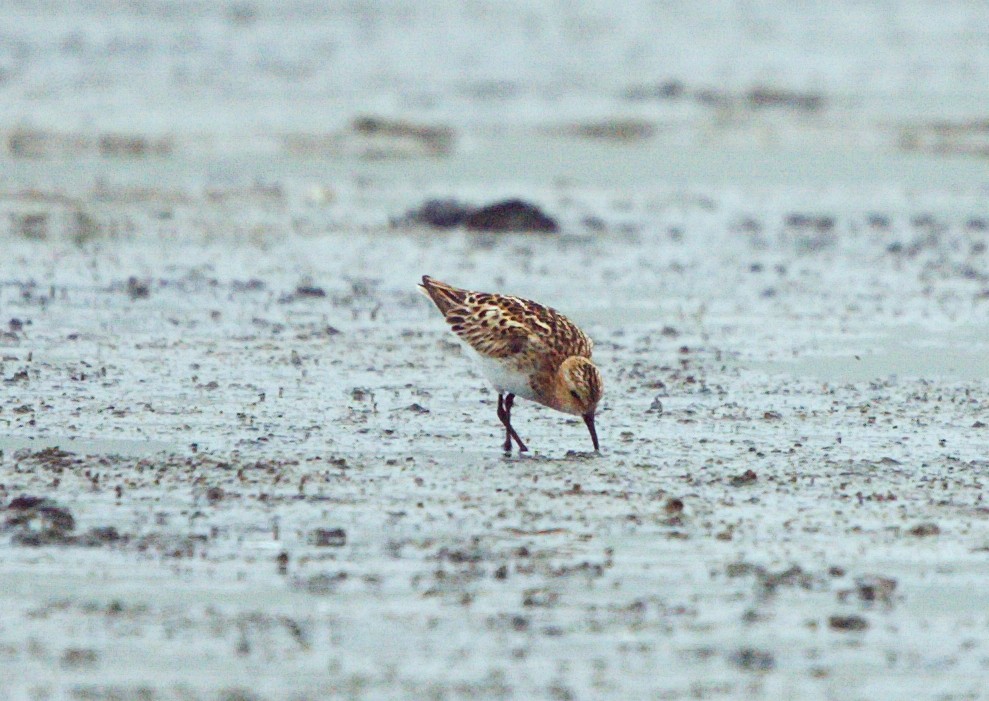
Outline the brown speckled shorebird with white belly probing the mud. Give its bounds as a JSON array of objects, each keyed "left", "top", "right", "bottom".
[{"left": 419, "top": 275, "right": 604, "bottom": 453}]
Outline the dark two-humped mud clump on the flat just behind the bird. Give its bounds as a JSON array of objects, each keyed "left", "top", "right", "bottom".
[{"left": 392, "top": 199, "right": 560, "bottom": 233}]
